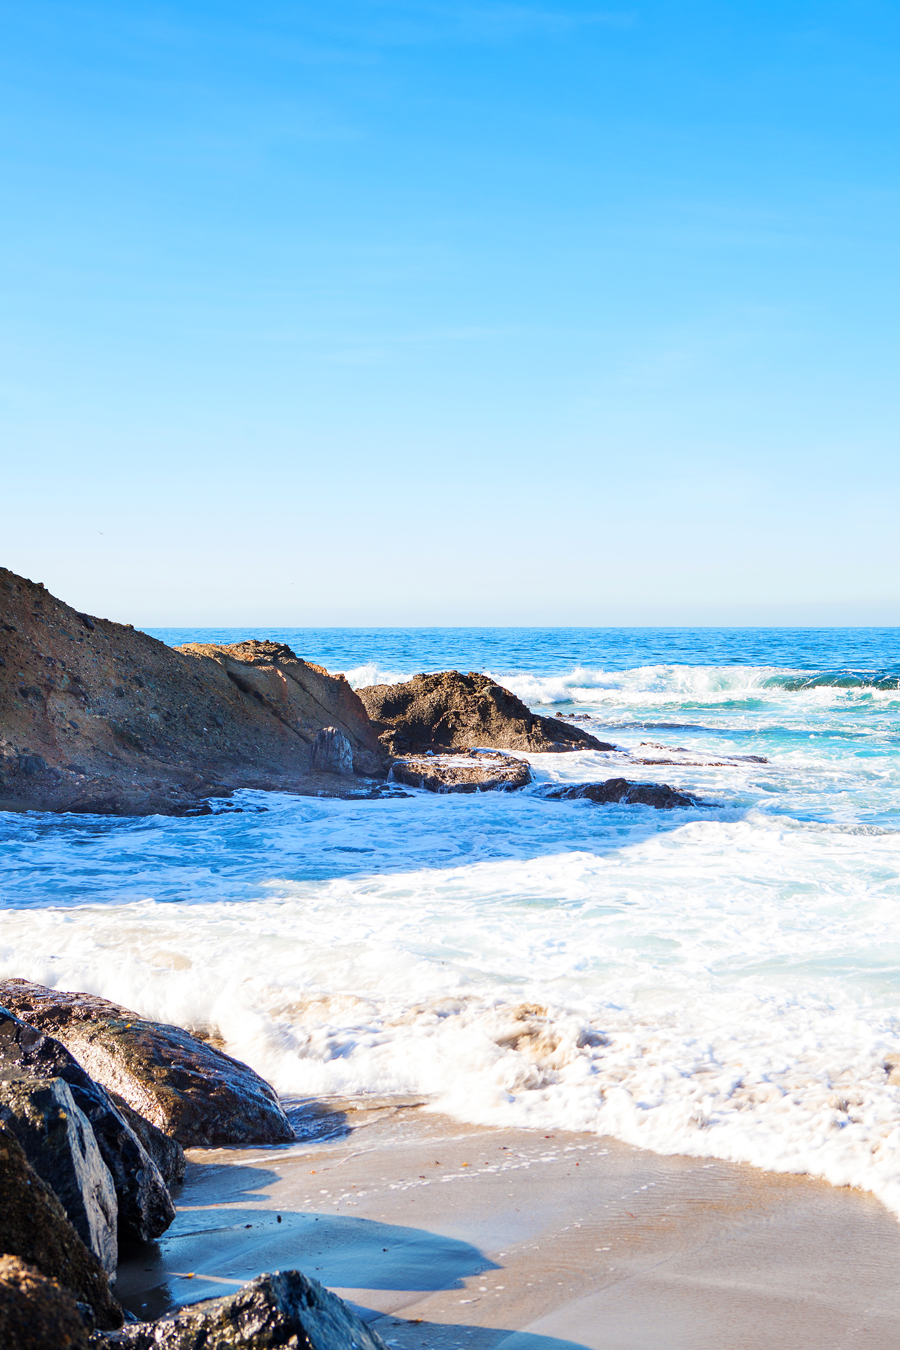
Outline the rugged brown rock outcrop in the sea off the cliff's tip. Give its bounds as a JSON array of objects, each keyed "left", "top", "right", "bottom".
[{"left": 358, "top": 671, "right": 615, "bottom": 756}]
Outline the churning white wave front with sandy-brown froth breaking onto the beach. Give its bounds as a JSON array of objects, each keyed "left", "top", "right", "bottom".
[{"left": 0, "top": 923, "right": 900, "bottom": 1216}]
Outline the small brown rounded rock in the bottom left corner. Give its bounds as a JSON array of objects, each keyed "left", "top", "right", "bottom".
[{"left": 0, "top": 1256, "right": 88, "bottom": 1350}]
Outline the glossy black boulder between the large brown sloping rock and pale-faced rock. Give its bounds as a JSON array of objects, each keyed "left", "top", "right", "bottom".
[{"left": 0, "top": 1004, "right": 176, "bottom": 1242}]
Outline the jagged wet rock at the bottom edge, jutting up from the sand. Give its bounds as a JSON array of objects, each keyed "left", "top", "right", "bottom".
[{"left": 93, "top": 1270, "right": 386, "bottom": 1350}]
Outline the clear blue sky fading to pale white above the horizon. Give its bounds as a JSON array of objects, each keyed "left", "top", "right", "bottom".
[{"left": 0, "top": 0, "right": 900, "bottom": 625}]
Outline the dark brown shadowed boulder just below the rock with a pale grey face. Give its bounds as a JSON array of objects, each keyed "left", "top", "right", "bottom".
[{"left": 0, "top": 1125, "right": 123, "bottom": 1323}]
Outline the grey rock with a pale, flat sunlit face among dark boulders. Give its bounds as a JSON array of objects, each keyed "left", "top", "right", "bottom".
[{"left": 0, "top": 1077, "right": 119, "bottom": 1274}]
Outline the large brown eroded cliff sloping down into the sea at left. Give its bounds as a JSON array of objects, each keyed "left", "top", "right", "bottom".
[{"left": 0, "top": 568, "right": 387, "bottom": 815}]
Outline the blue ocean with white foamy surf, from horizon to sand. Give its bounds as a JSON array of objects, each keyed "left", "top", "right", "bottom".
[{"left": 0, "top": 628, "right": 900, "bottom": 1215}]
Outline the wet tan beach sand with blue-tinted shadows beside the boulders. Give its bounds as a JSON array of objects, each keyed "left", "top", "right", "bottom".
[{"left": 116, "top": 1108, "right": 900, "bottom": 1350}]
